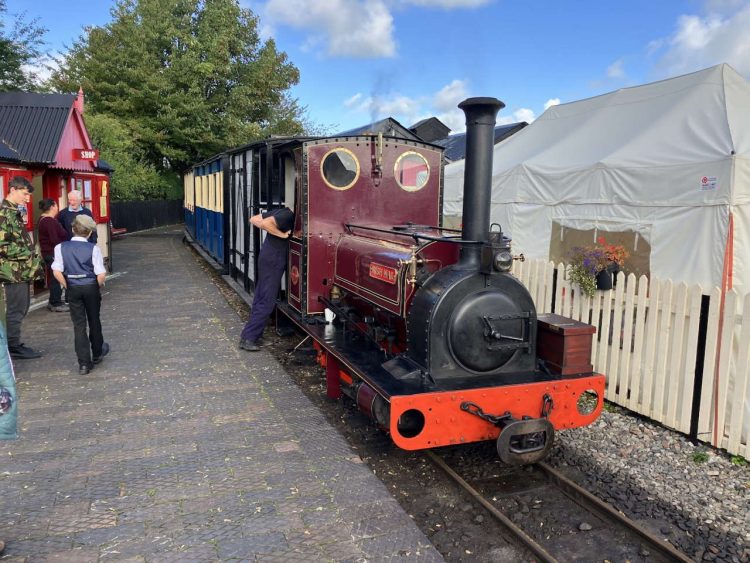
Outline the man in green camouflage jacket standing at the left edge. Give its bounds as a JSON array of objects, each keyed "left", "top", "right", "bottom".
[{"left": 0, "top": 176, "right": 44, "bottom": 360}]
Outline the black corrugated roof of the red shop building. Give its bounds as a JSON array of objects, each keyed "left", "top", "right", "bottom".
[{"left": 0, "top": 92, "right": 76, "bottom": 164}]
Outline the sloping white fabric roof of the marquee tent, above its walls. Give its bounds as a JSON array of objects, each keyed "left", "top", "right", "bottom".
[{"left": 446, "top": 64, "right": 750, "bottom": 206}]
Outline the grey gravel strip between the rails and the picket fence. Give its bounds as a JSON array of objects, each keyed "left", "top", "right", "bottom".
[{"left": 548, "top": 407, "right": 750, "bottom": 563}]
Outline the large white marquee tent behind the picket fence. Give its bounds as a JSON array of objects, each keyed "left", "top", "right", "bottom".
[{"left": 445, "top": 64, "right": 750, "bottom": 292}]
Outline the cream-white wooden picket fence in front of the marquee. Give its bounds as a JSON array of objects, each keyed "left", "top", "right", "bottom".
[{"left": 513, "top": 260, "right": 750, "bottom": 459}]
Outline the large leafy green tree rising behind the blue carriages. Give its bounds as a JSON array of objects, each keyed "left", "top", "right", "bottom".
[{"left": 51, "top": 0, "right": 303, "bottom": 172}]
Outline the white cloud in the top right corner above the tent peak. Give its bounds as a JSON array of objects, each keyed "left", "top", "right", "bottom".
[{"left": 650, "top": 0, "right": 750, "bottom": 76}]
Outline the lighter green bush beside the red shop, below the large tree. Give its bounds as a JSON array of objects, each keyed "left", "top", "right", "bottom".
[{"left": 85, "top": 114, "right": 182, "bottom": 200}]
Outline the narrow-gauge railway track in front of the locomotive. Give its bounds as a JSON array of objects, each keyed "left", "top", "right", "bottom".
[{"left": 426, "top": 451, "right": 692, "bottom": 563}]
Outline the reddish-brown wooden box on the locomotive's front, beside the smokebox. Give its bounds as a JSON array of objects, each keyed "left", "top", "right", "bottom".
[{"left": 537, "top": 313, "right": 596, "bottom": 375}]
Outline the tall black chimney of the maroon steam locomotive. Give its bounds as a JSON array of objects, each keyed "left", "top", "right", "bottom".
[{"left": 458, "top": 98, "right": 505, "bottom": 268}]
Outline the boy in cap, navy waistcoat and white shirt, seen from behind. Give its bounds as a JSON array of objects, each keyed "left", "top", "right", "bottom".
[{"left": 52, "top": 214, "right": 109, "bottom": 375}]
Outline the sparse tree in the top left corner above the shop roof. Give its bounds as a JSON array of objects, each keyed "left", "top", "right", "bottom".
[{"left": 0, "top": 0, "right": 47, "bottom": 92}]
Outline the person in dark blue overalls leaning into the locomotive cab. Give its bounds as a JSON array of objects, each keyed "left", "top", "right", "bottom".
[{"left": 240, "top": 207, "right": 294, "bottom": 352}]
